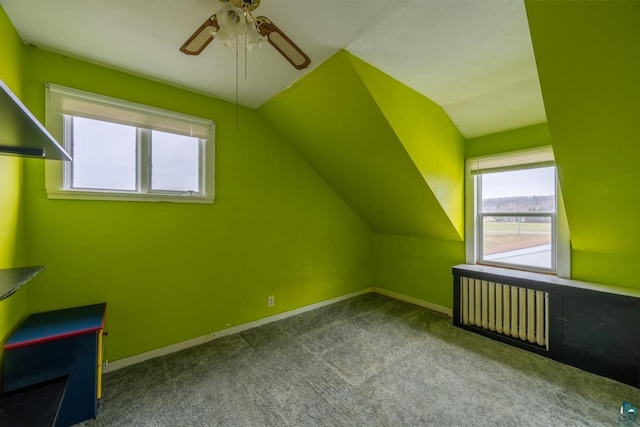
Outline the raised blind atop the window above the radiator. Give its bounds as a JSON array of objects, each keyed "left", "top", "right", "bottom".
[{"left": 469, "top": 146, "right": 555, "bottom": 175}]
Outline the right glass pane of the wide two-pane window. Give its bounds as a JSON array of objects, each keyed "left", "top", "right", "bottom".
[{"left": 151, "top": 131, "right": 200, "bottom": 192}]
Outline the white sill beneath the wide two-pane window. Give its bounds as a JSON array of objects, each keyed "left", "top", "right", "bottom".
[{"left": 47, "top": 190, "right": 214, "bottom": 204}]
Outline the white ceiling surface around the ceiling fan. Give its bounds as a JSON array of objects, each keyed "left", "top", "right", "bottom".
[{"left": 0, "top": 0, "right": 546, "bottom": 137}]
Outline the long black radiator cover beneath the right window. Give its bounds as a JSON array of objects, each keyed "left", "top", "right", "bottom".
[{"left": 453, "top": 264, "right": 640, "bottom": 388}]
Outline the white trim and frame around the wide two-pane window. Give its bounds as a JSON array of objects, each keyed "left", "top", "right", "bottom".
[{"left": 45, "top": 83, "right": 215, "bottom": 203}]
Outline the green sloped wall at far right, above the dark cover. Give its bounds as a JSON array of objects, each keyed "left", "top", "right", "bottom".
[{"left": 526, "top": 1, "right": 640, "bottom": 288}]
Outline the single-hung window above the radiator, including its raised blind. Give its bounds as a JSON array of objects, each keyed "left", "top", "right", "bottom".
[{"left": 467, "top": 147, "right": 568, "bottom": 273}]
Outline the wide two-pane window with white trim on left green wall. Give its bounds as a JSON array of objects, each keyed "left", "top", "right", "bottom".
[{"left": 47, "top": 84, "right": 214, "bottom": 203}]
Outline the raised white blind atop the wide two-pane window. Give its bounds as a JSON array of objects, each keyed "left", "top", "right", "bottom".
[{"left": 46, "top": 83, "right": 214, "bottom": 139}]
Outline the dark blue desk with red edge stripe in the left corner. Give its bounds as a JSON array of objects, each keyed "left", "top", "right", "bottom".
[{"left": 3, "top": 303, "right": 107, "bottom": 426}]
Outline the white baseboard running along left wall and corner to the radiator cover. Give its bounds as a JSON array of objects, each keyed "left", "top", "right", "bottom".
[{"left": 103, "top": 287, "right": 453, "bottom": 374}]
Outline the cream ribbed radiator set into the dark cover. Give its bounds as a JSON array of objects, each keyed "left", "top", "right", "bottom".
[{"left": 460, "top": 277, "right": 549, "bottom": 350}]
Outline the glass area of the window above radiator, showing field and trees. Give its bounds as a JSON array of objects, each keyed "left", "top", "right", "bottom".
[{"left": 478, "top": 167, "right": 556, "bottom": 270}]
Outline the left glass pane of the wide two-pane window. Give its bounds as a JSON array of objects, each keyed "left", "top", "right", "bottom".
[{"left": 71, "top": 117, "right": 137, "bottom": 190}]
